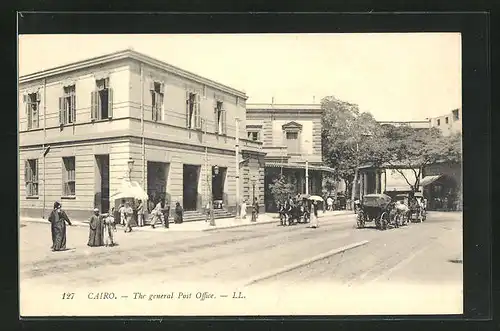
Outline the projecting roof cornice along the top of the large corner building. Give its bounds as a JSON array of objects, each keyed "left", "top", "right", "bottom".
[{"left": 19, "top": 49, "right": 248, "bottom": 100}]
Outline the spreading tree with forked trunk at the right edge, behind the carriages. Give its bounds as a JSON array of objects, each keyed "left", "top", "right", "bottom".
[{"left": 370, "top": 126, "right": 462, "bottom": 193}]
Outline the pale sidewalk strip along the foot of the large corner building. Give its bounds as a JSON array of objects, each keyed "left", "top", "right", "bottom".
[{"left": 20, "top": 210, "right": 352, "bottom": 232}]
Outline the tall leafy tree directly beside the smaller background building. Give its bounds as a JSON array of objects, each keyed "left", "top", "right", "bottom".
[{"left": 321, "top": 96, "right": 380, "bottom": 198}]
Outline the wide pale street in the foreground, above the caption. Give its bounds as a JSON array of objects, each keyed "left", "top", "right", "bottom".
[{"left": 20, "top": 212, "right": 462, "bottom": 314}]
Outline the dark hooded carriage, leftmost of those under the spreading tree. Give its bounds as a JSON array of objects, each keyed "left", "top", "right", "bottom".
[{"left": 357, "top": 194, "right": 392, "bottom": 230}]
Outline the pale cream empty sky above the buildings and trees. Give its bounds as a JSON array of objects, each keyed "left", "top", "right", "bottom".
[{"left": 18, "top": 33, "right": 462, "bottom": 121}]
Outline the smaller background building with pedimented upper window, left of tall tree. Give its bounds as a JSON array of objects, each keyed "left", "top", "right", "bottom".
[{"left": 246, "top": 104, "right": 332, "bottom": 211}]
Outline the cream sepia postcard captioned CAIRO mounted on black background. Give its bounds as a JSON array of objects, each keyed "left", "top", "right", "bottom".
[{"left": 17, "top": 33, "right": 464, "bottom": 317}]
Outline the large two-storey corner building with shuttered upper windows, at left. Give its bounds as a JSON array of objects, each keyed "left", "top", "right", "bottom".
[{"left": 19, "top": 50, "right": 264, "bottom": 218}]
